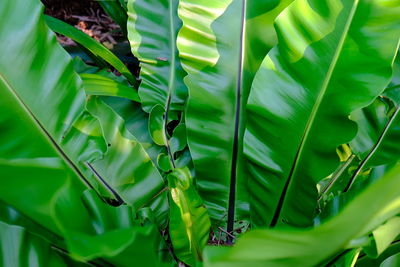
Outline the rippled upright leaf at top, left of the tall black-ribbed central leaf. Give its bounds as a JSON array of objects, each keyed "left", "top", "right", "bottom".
[{"left": 128, "top": 0, "right": 187, "bottom": 113}]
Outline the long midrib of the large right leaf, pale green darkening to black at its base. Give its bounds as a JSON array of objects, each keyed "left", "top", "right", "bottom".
[{"left": 270, "top": 0, "right": 359, "bottom": 227}]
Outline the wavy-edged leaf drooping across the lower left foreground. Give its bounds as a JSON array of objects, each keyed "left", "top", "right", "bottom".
[{"left": 0, "top": 158, "right": 158, "bottom": 266}]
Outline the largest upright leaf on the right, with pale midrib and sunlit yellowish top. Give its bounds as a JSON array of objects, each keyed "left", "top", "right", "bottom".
[{"left": 245, "top": 0, "right": 400, "bottom": 226}]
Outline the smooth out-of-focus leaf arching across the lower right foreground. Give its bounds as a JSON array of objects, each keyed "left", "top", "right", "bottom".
[{"left": 205, "top": 166, "right": 400, "bottom": 267}]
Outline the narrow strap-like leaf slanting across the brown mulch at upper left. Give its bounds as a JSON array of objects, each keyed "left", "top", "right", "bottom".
[{"left": 45, "top": 16, "right": 138, "bottom": 87}]
